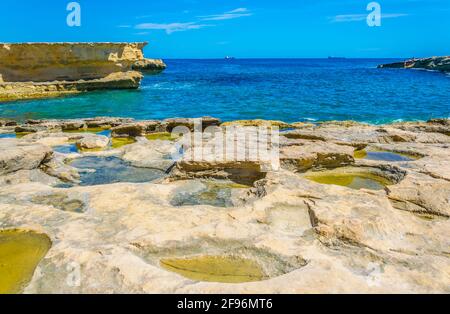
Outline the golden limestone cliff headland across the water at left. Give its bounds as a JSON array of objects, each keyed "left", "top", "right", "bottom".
[{"left": 0, "top": 43, "right": 165, "bottom": 101}]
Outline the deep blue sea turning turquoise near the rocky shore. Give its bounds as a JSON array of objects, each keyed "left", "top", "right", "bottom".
[{"left": 0, "top": 59, "right": 450, "bottom": 123}]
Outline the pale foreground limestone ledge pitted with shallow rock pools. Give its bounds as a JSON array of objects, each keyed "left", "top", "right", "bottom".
[{"left": 0, "top": 117, "right": 450, "bottom": 293}]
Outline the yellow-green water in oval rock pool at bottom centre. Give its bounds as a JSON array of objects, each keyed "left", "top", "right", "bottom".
[{"left": 160, "top": 256, "right": 268, "bottom": 283}]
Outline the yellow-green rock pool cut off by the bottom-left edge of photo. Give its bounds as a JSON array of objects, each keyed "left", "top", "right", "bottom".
[{"left": 0, "top": 230, "right": 52, "bottom": 294}]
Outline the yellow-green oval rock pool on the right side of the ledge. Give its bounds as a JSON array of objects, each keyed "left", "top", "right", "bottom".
[{"left": 305, "top": 171, "right": 392, "bottom": 190}]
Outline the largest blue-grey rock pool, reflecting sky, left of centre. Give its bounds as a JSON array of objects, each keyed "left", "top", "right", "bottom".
[{"left": 70, "top": 156, "right": 165, "bottom": 186}]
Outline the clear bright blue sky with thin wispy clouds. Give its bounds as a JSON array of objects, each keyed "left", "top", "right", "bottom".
[{"left": 0, "top": 0, "right": 450, "bottom": 58}]
